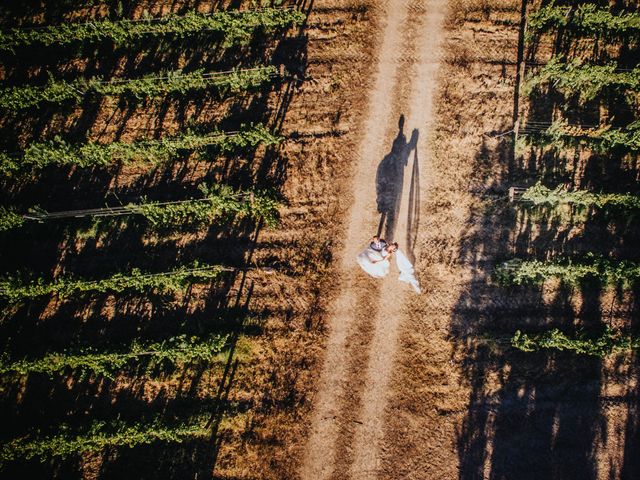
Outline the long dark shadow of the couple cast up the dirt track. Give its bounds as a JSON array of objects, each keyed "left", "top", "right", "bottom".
[{"left": 376, "top": 115, "right": 420, "bottom": 262}]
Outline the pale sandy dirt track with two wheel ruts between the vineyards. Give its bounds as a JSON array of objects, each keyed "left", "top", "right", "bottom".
[{"left": 301, "top": 0, "right": 446, "bottom": 480}]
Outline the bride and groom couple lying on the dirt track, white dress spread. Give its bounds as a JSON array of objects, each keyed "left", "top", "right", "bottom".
[{"left": 357, "top": 235, "right": 421, "bottom": 293}]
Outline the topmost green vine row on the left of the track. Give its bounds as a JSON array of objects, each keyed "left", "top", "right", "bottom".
[{"left": 0, "top": 8, "right": 306, "bottom": 51}]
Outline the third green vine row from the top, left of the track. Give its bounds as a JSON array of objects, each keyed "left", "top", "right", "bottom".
[{"left": 0, "top": 125, "right": 283, "bottom": 175}]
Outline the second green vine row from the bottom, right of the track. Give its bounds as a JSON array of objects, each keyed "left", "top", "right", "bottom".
[{"left": 494, "top": 255, "right": 640, "bottom": 288}]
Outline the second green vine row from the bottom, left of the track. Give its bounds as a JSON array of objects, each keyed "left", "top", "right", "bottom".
[{"left": 0, "top": 335, "right": 228, "bottom": 378}]
